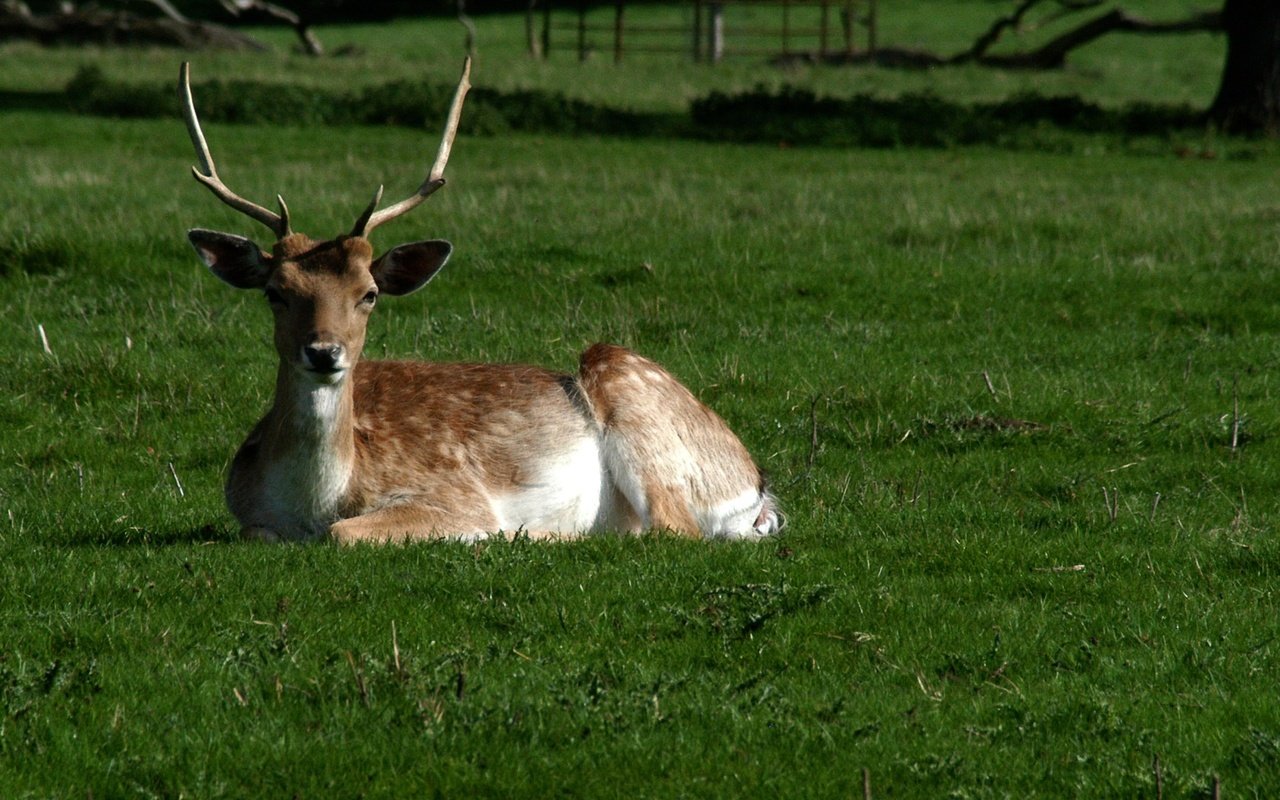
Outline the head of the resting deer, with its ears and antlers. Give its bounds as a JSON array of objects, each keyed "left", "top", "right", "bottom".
[{"left": 179, "top": 59, "right": 471, "bottom": 384}]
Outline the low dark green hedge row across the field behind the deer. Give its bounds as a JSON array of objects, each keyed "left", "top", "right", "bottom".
[{"left": 67, "top": 68, "right": 1203, "bottom": 147}]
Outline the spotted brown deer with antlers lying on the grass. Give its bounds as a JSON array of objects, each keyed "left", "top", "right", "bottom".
[{"left": 178, "top": 59, "right": 785, "bottom": 544}]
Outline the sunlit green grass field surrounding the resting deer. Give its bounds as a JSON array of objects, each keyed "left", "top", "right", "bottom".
[{"left": 0, "top": 0, "right": 1280, "bottom": 797}]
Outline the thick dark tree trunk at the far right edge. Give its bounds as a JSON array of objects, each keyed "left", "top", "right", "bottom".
[{"left": 1208, "top": 0, "right": 1280, "bottom": 133}]
